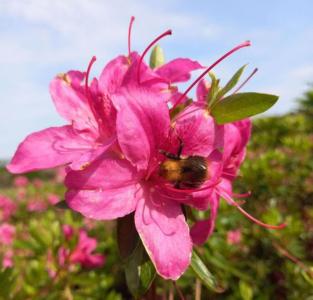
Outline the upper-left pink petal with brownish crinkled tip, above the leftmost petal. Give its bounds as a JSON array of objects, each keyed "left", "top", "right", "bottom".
[{"left": 50, "top": 71, "right": 97, "bottom": 134}]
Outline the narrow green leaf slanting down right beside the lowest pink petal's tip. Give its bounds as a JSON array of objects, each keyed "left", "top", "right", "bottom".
[{"left": 190, "top": 251, "right": 224, "bottom": 293}]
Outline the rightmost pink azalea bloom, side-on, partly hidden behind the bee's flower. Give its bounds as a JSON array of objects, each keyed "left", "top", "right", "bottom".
[{"left": 191, "top": 80, "right": 286, "bottom": 245}]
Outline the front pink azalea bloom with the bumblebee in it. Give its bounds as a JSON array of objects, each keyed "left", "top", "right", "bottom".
[{"left": 65, "top": 81, "right": 222, "bottom": 279}]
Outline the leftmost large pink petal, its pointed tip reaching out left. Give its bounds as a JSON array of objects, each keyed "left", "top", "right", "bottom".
[{"left": 7, "top": 126, "right": 91, "bottom": 173}]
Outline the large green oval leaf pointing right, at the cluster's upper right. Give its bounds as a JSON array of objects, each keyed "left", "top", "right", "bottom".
[{"left": 211, "top": 93, "right": 278, "bottom": 124}]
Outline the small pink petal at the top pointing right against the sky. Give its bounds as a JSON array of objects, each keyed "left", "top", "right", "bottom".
[{"left": 156, "top": 58, "right": 203, "bottom": 83}]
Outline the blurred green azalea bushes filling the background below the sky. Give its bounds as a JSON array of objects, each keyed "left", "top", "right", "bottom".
[{"left": 0, "top": 90, "right": 313, "bottom": 300}]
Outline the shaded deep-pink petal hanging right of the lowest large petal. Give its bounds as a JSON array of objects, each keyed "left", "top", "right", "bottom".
[{"left": 190, "top": 194, "right": 219, "bottom": 245}]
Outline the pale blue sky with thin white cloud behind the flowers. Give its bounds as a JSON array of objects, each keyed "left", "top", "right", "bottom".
[{"left": 0, "top": 0, "right": 313, "bottom": 159}]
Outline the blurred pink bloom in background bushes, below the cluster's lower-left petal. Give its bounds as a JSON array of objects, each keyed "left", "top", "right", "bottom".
[{"left": 58, "top": 226, "right": 105, "bottom": 268}]
